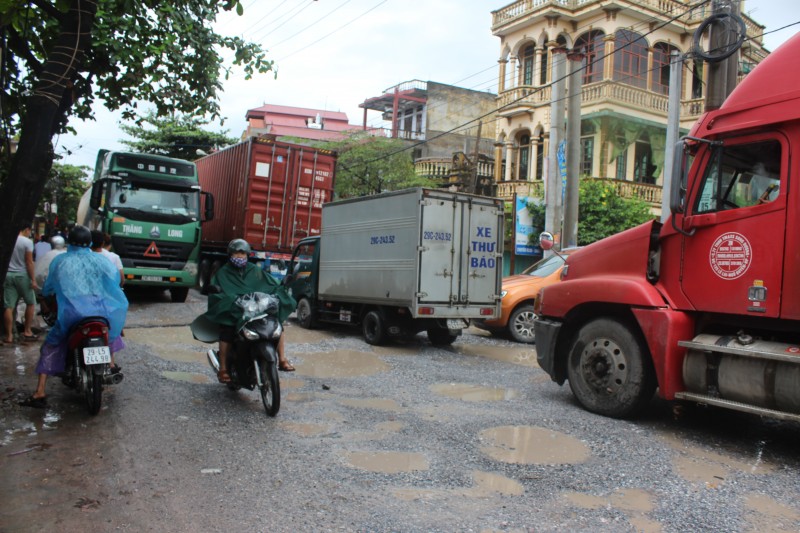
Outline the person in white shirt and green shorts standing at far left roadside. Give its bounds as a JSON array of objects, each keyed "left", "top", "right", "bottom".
[{"left": 3, "top": 222, "right": 39, "bottom": 344}]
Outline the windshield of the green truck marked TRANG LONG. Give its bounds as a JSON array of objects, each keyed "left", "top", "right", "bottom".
[{"left": 108, "top": 181, "right": 200, "bottom": 224}]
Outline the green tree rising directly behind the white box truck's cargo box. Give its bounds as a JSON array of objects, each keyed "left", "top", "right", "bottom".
[{"left": 321, "top": 132, "right": 437, "bottom": 198}]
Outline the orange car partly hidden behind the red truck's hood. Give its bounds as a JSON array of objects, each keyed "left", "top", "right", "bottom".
[{"left": 472, "top": 248, "right": 580, "bottom": 343}]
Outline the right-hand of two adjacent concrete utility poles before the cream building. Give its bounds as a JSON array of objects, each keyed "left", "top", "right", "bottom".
[{"left": 561, "top": 50, "right": 584, "bottom": 250}]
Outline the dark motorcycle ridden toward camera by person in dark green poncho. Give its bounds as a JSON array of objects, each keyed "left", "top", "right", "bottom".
[{"left": 190, "top": 286, "right": 283, "bottom": 416}]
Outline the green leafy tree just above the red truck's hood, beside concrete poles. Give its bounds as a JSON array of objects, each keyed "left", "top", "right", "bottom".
[{"left": 578, "top": 178, "right": 655, "bottom": 246}]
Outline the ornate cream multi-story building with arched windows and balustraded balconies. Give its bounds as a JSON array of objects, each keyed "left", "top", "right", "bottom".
[{"left": 492, "top": 0, "right": 767, "bottom": 214}]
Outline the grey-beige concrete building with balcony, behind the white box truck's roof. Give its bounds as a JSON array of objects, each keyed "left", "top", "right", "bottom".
[{"left": 359, "top": 80, "right": 497, "bottom": 188}]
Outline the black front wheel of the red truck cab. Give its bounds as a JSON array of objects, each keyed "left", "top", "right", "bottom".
[{"left": 567, "top": 318, "right": 656, "bottom": 418}]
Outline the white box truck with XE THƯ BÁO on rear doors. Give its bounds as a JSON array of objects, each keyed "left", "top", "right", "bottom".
[{"left": 289, "top": 188, "right": 503, "bottom": 345}]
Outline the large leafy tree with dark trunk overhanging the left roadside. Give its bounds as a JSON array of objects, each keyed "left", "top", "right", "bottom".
[{"left": 0, "top": 0, "right": 272, "bottom": 281}]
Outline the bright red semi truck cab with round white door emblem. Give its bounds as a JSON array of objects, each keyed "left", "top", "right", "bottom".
[{"left": 535, "top": 34, "right": 800, "bottom": 421}]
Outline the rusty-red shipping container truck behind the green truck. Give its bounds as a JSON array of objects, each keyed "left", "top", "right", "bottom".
[{"left": 195, "top": 137, "right": 336, "bottom": 292}]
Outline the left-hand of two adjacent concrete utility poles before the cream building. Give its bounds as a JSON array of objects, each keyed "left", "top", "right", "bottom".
[{"left": 544, "top": 46, "right": 567, "bottom": 252}]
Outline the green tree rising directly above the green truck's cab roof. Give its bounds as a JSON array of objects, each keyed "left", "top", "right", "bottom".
[{"left": 120, "top": 111, "right": 238, "bottom": 161}]
